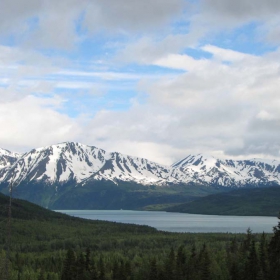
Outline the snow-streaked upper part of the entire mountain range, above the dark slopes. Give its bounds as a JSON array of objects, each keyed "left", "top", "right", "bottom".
[{"left": 0, "top": 142, "right": 280, "bottom": 187}]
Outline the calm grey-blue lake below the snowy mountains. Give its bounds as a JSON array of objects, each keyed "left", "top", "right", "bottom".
[{"left": 58, "top": 210, "right": 278, "bottom": 233}]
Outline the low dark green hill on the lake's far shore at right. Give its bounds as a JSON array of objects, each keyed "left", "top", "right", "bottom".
[{"left": 166, "top": 187, "right": 280, "bottom": 216}]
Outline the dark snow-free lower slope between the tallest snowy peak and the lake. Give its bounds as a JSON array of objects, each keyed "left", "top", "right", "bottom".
[{"left": 0, "top": 180, "right": 224, "bottom": 210}]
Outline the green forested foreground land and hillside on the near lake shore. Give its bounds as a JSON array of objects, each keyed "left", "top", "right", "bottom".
[{"left": 0, "top": 195, "right": 280, "bottom": 280}]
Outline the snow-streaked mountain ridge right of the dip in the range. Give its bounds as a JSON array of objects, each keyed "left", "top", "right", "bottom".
[{"left": 172, "top": 154, "right": 280, "bottom": 187}]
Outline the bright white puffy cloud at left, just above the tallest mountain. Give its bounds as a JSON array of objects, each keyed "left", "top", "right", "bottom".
[{"left": 0, "top": 96, "right": 80, "bottom": 151}]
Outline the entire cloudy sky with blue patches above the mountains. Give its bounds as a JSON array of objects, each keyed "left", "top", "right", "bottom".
[{"left": 0, "top": 0, "right": 280, "bottom": 165}]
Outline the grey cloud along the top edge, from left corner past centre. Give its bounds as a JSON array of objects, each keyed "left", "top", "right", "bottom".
[{"left": 0, "top": 0, "right": 184, "bottom": 49}]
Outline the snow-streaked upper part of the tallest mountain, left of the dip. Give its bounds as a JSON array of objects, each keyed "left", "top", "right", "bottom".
[{"left": 0, "top": 142, "right": 174, "bottom": 185}]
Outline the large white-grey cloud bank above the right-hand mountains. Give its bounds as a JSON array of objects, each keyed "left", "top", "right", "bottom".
[{"left": 73, "top": 45, "right": 280, "bottom": 163}]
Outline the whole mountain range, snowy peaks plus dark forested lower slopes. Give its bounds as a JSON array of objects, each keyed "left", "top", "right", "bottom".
[{"left": 0, "top": 142, "right": 280, "bottom": 209}]
